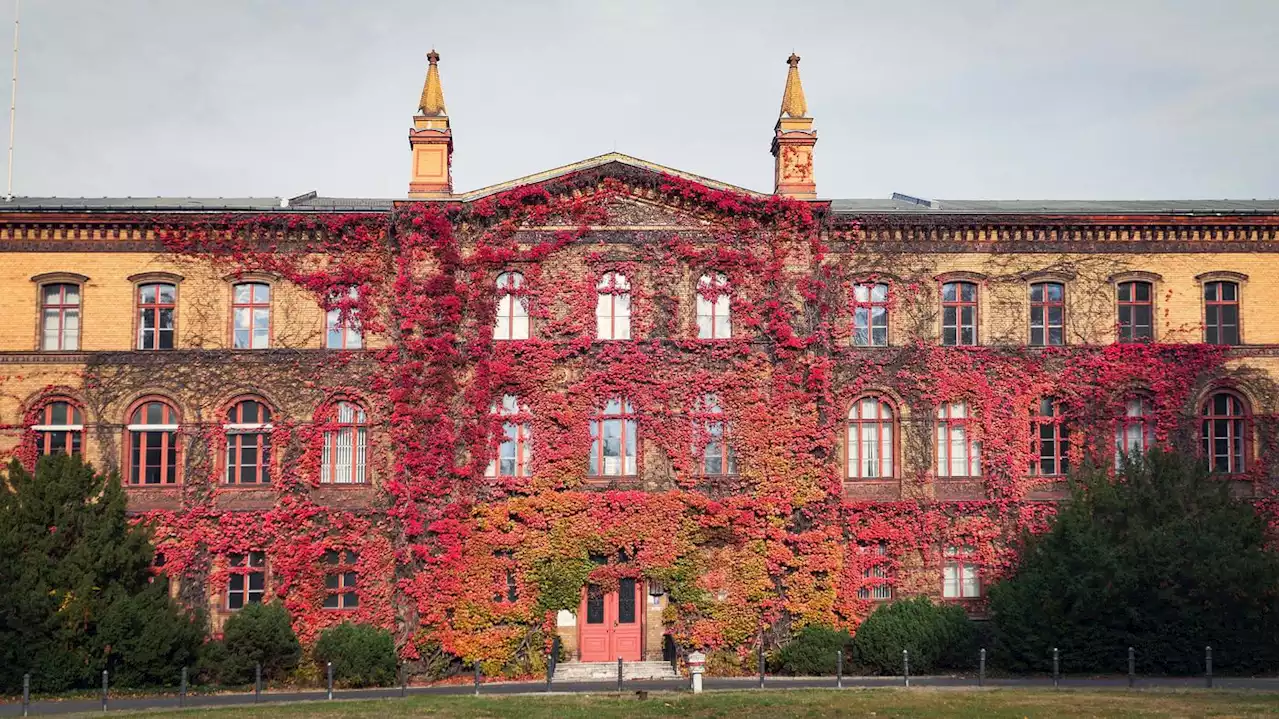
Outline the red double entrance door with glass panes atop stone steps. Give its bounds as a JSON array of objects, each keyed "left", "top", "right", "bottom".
[{"left": 577, "top": 578, "right": 644, "bottom": 661}]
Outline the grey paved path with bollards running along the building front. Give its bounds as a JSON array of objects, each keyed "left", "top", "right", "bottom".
[{"left": 0, "top": 676, "right": 1280, "bottom": 716}]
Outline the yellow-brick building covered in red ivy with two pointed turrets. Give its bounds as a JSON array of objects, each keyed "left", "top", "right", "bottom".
[{"left": 0, "top": 52, "right": 1280, "bottom": 673}]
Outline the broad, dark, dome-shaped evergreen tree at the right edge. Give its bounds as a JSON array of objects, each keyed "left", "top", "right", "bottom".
[{"left": 991, "top": 450, "right": 1280, "bottom": 674}]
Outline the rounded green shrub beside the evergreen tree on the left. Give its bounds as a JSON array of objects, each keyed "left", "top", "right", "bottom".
[{"left": 200, "top": 603, "right": 302, "bottom": 684}]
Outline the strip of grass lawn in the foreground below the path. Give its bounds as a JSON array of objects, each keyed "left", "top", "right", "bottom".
[{"left": 127, "top": 688, "right": 1280, "bottom": 719}]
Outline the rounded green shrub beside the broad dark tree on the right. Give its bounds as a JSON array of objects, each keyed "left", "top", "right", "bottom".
[{"left": 854, "top": 596, "right": 977, "bottom": 674}]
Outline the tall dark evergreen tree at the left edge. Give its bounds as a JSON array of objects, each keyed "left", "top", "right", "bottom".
[{"left": 0, "top": 454, "right": 202, "bottom": 692}]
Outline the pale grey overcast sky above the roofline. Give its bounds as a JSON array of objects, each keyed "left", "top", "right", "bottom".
[{"left": 0, "top": 0, "right": 1280, "bottom": 200}]
